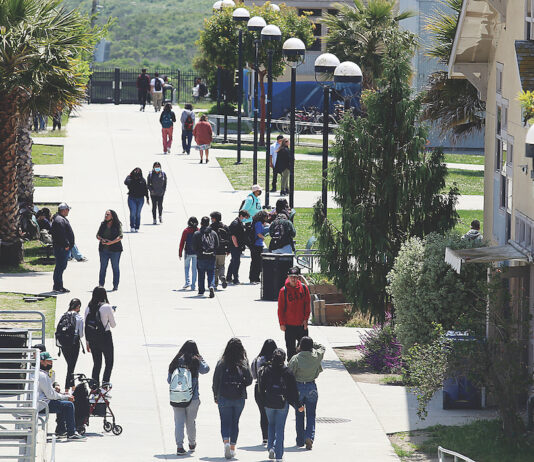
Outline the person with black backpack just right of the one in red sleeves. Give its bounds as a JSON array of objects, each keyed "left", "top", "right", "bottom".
[{"left": 193, "top": 217, "right": 219, "bottom": 298}]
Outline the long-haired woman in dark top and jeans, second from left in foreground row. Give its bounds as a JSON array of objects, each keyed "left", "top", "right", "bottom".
[{"left": 212, "top": 338, "right": 252, "bottom": 459}]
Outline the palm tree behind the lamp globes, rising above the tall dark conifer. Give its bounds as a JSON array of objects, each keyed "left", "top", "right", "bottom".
[{"left": 322, "top": 0, "right": 414, "bottom": 89}]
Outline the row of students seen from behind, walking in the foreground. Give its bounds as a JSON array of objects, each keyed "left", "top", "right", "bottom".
[{"left": 167, "top": 337, "right": 325, "bottom": 461}]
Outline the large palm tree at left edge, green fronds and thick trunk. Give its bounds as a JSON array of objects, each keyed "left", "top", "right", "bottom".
[{"left": 0, "top": 0, "right": 98, "bottom": 265}]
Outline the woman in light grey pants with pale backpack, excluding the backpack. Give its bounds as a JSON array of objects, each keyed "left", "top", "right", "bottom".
[{"left": 167, "top": 340, "right": 210, "bottom": 456}]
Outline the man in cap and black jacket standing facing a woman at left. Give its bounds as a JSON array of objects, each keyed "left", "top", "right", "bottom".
[{"left": 50, "top": 202, "right": 74, "bottom": 293}]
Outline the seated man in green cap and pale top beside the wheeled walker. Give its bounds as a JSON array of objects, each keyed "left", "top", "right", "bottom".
[{"left": 38, "top": 351, "right": 85, "bottom": 440}]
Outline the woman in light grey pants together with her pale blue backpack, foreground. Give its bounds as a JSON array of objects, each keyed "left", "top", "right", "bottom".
[{"left": 167, "top": 340, "right": 210, "bottom": 456}]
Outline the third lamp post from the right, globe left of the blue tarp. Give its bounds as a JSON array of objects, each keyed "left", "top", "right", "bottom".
[{"left": 282, "top": 38, "right": 306, "bottom": 208}]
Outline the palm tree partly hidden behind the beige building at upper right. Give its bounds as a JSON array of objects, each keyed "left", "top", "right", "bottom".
[{"left": 423, "top": 0, "right": 486, "bottom": 140}]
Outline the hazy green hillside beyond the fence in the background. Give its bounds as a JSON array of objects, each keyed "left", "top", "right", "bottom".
[{"left": 65, "top": 0, "right": 215, "bottom": 70}]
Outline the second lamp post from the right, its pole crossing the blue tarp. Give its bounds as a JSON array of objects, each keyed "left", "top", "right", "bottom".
[{"left": 315, "top": 53, "right": 340, "bottom": 217}]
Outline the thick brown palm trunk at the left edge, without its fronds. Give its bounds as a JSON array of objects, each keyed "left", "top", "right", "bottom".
[{"left": 0, "top": 93, "right": 22, "bottom": 266}]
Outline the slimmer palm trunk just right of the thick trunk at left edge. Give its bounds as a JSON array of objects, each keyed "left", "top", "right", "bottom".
[{"left": 17, "top": 117, "right": 34, "bottom": 204}]
